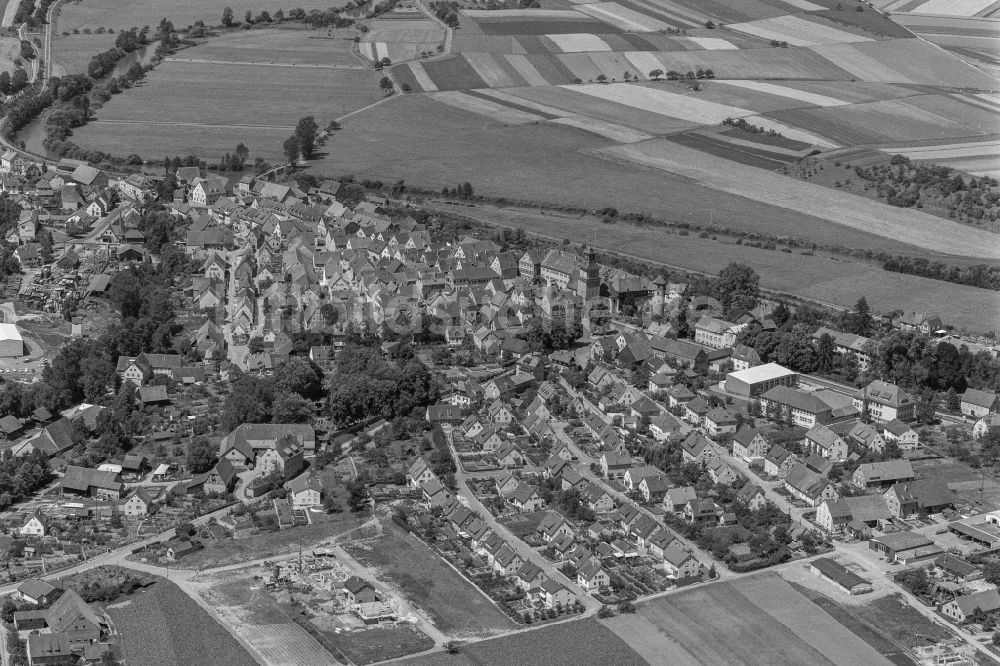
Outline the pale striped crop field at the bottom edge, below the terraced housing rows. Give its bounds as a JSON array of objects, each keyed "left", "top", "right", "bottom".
[{"left": 605, "top": 575, "right": 892, "bottom": 666}]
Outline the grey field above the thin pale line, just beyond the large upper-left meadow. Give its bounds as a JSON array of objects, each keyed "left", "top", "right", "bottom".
[{"left": 188, "top": 29, "right": 365, "bottom": 68}]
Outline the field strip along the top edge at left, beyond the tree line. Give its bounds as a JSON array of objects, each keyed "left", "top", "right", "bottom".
[{"left": 58, "top": 0, "right": 329, "bottom": 31}]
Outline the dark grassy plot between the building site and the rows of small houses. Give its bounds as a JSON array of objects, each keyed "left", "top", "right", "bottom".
[{"left": 344, "top": 522, "right": 514, "bottom": 636}]
